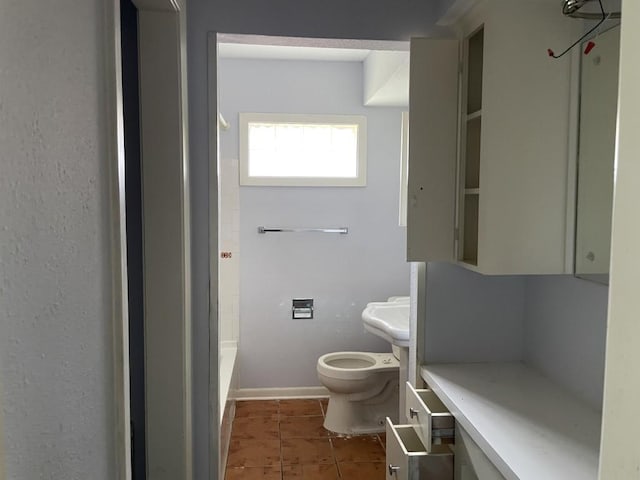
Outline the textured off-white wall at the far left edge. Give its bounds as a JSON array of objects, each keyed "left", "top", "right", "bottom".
[{"left": 0, "top": 0, "right": 115, "bottom": 480}]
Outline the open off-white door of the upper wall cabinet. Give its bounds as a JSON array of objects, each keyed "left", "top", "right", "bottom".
[{"left": 407, "top": 38, "right": 459, "bottom": 261}]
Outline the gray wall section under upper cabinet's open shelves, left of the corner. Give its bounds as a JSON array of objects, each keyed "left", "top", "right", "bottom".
[{"left": 424, "top": 263, "right": 525, "bottom": 363}]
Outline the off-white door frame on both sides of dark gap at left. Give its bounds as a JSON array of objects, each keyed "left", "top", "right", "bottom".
[{"left": 105, "top": 0, "right": 193, "bottom": 480}]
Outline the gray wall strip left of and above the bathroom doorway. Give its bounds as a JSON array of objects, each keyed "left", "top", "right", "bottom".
[{"left": 187, "top": 0, "right": 448, "bottom": 478}]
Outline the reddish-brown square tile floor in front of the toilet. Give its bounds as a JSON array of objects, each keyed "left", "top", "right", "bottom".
[{"left": 225, "top": 399, "right": 385, "bottom": 480}]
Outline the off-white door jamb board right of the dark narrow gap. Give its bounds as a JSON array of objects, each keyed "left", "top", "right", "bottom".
[{"left": 134, "top": 0, "right": 193, "bottom": 480}]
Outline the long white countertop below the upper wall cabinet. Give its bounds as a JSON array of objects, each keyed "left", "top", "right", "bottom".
[{"left": 421, "top": 363, "right": 601, "bottom": 480}]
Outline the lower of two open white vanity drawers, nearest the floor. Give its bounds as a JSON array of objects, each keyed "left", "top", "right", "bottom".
[{"left": 386, "top": 418, "right": 453, "bottom": 480}]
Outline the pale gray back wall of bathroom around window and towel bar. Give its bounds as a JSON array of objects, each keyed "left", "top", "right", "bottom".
[{"left": 219, "top": 60, "right": 409, "bottom": 388}]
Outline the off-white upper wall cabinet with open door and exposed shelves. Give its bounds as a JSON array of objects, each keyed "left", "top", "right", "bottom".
[{"left": 407, "top": 0, "right": 575, "bottom": 274}]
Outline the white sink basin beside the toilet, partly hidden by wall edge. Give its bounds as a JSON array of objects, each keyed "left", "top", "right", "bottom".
[{"left": 362, "top": 301, "right": 409, "bottom": 347}]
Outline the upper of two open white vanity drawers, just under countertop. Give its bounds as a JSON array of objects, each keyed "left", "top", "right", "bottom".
[{"left": 405, "top": 382, "right": 455, "bottom": 451}]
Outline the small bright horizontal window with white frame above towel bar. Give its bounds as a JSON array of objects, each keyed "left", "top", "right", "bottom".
[{"left": 240, "top": 113, "right": 367, "bottom": 187}]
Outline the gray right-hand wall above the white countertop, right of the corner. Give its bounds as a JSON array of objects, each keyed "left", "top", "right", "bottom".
[{"left": 524, "top": 275, "right": 609, "bottom": 410}]
